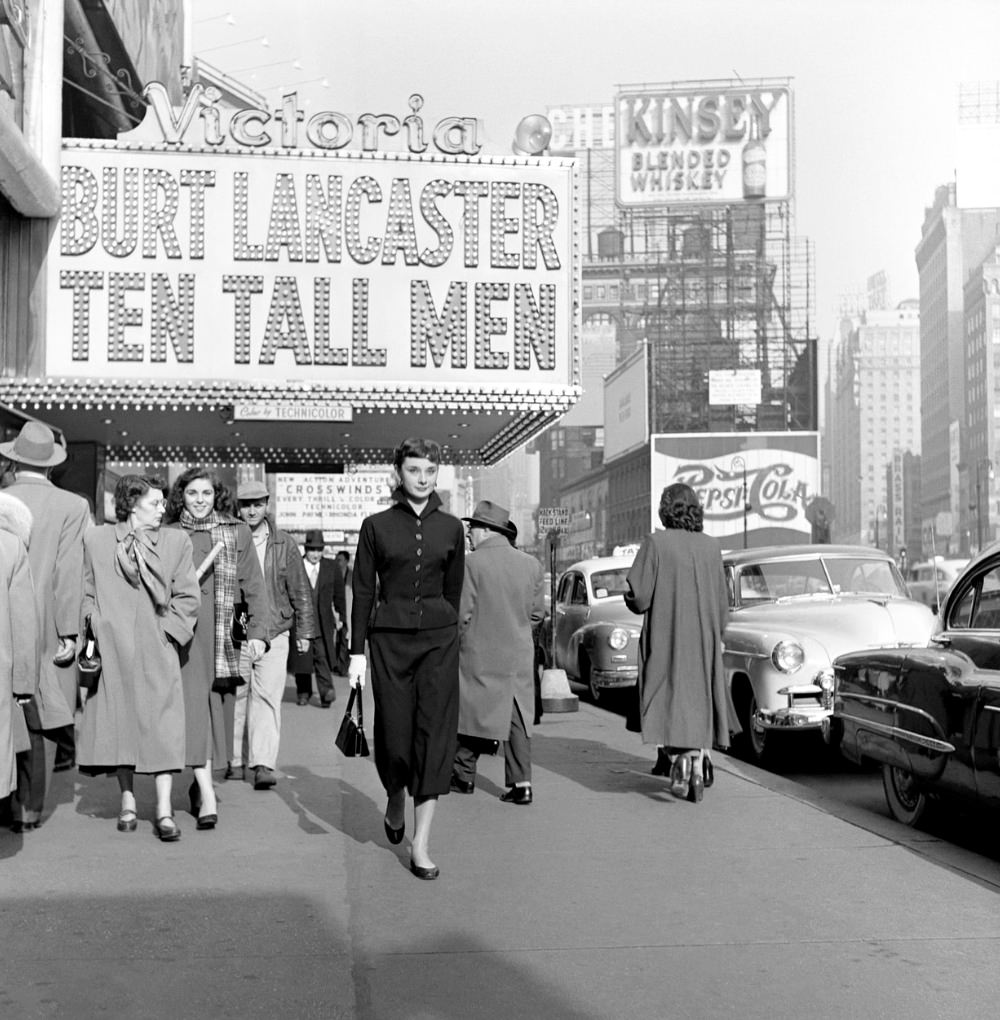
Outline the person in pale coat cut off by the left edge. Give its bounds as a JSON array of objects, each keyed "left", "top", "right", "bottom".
[{"left": 0, "top": 493, "right": 38, "bottom": 832}]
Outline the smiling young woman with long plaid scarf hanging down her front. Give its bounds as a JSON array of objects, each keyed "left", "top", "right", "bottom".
[{"left": 166, "top": 467, "right": 266, "bottom": 829}]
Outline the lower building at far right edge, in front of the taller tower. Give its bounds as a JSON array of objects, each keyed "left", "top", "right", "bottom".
[{"left": 962, "top": 244, "right": 1000, "bottom": 550}]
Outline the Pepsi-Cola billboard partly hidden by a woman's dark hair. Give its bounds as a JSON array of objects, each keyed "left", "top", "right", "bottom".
[{"left": 649, "top": 432, "right": 819, "bottom": 549}]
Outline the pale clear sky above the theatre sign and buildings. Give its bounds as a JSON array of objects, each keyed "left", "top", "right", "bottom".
[{"left": 192, "top": 0, "right": 1000, "bottom": 339}]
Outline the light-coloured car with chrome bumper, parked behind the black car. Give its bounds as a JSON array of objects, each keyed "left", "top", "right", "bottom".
[{"left": 723, "top": 545, "right": 935, "bottom": 762}]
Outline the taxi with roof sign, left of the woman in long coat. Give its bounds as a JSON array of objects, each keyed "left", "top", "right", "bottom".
[{"left": 539, "top": 556, "right": 642, "bottom": 701}]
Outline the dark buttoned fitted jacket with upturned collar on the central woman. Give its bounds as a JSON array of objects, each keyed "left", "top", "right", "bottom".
[{"left": 351, "top": 489, "right": 465, "bottom": 655}]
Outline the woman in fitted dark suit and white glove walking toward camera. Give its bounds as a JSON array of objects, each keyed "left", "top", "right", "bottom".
[{"left": 349, "top": 439, "right": 465, "bottom": 879}]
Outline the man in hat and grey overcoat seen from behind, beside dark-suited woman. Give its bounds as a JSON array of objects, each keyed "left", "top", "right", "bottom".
[{"left": 451, "top": 500, "right": 545, "bottom": 804}]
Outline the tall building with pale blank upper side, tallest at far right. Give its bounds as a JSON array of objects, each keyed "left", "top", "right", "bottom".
[{"left": 915, "top": 184, "right": 1000, "bottom": 553}]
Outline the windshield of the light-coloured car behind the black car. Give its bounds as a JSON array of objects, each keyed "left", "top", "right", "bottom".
[{"left": 737, "top": 557, "right": 906, "bottom": 605}]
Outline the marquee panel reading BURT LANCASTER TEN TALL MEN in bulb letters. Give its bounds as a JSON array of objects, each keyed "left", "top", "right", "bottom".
[{"left": 46, "top": 129, "right": 579, "bottom": 383}]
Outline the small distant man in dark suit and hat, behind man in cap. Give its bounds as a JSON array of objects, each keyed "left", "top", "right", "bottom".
[{"left": 292, "top": 530, "right": 347, "bottom": 708}]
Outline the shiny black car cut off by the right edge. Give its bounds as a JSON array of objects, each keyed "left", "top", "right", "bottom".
[{"left": 830, "top": 545, "right": 1000, "bottom": 825}]
